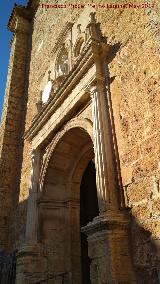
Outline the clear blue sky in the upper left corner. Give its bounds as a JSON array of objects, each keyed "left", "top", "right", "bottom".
[{"left": 0, "top": 0, "right": 28, "bottom": 120}]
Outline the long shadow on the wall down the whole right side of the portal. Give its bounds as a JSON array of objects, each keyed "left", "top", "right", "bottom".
[{"left": 106, "top": 42, "right": 160, "bottom": 284}]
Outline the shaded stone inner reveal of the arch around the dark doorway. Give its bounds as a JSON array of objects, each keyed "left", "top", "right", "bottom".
[{"left": 38, "top": 121, "right": 94, "bottom": 283}]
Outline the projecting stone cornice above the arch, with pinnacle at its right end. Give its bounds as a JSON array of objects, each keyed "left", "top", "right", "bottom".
[{"left": 24, "top": 14, "right": 110, "bottom": 141}]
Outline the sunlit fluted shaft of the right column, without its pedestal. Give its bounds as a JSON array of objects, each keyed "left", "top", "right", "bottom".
[{"left": 91, "top": 86, "right": 120, "bottom": 214}]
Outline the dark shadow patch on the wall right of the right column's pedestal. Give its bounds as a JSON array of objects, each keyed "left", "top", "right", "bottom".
[{"left": 130, "top": 215, "right": 160, "bottom": 284}]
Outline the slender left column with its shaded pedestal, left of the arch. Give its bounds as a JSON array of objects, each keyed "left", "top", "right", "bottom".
[{"left": 16, "top": 150, "right": 46, "bottom": 284}]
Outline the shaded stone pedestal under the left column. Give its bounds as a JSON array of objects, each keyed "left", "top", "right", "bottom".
[{"left": 16, "top": 244, "right": 47, "bottom": 284}]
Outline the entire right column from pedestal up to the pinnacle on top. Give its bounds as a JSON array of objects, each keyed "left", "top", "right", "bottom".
[{"left": 82, "top": 13, "right": 136, "bottom": 284}]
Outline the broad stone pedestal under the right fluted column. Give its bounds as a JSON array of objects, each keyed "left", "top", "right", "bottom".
[{"left": 82, "top": 211, "right": 136, "bottom": 284}]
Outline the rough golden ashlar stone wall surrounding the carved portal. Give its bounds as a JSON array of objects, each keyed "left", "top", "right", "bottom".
[{"left": 0, "top": 0, "right": 160, "bottom": 283}]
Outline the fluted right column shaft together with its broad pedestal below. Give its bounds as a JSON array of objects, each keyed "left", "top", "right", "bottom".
[{"left": 82, "top": 86, "right": 136, "bottom": 284}]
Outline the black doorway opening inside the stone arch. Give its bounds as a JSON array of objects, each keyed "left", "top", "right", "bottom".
[{"left": 80, "top": 161, "right": 99, "bottom": 284}]
